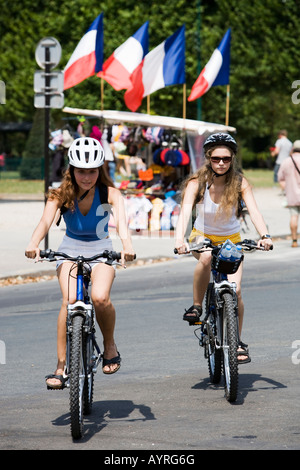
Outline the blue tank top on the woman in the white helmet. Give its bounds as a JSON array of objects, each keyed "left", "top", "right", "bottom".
[{"left": 63, "top": 187, "right": 110, "bottom": 242}]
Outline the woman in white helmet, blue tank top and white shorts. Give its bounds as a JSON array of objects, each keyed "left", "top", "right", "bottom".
[{"left": 25, "top": 137, "right": 134, "bottom": 388}]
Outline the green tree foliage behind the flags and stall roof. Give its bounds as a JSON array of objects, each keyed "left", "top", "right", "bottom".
[{"left": 0, "top": 0, "right": 300, "bottom": 163}]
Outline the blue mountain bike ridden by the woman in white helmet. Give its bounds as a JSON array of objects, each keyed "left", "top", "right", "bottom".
[{"left": 40, "top": 249, "right": 121, "bottom": 439}]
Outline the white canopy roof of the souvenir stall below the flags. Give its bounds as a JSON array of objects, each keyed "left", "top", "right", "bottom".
[{"left": 63, "top": 107, "right": 236, "bottom": 171}]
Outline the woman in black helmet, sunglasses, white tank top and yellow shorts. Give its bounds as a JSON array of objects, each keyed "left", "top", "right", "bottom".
[{"left": 175, "top": 133, "right": 272, "bottom": 363}]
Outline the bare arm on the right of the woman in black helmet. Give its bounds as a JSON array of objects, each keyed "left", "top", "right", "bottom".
[{"left": 242, "top": 178, "right": 273, "bottom": 250}]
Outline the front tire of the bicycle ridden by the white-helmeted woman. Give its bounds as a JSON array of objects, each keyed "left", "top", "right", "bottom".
[{"left": 70, "top": 315, "right": 85, "bottom": 439}]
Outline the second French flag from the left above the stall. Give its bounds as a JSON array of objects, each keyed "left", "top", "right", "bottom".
[{"left": 98, "top": 21, "right": 149, "bottom": 91}]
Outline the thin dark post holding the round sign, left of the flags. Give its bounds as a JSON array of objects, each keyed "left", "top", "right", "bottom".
[{"left": 44, "top": 47, "right": 51, "bottom": 250}]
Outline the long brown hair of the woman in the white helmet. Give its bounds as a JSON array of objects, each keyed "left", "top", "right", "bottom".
[{"left": 47, "top": 165, "right": 114, "bottom": 210}]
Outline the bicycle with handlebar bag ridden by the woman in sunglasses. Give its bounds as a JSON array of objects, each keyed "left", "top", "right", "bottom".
[{"left": 174, "top": 238, "right": 272, "bottom": 402}]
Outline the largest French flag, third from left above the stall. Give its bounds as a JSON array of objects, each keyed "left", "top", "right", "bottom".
[{"left": 124, "top": 25, "right": 185, "bottom": 111}]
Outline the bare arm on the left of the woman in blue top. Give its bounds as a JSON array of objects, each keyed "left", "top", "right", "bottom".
[{"left": 25, "top": 199, "right": 60, "bottom": 258}]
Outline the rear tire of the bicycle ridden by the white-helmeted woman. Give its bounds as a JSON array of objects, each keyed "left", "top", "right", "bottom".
[{"left": 83, "top": 335, "right": 94, "bottom": 415}]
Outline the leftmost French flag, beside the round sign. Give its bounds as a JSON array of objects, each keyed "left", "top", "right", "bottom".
[{"left": 64, "top": 13, "right": 104, "bottom": 90}]
